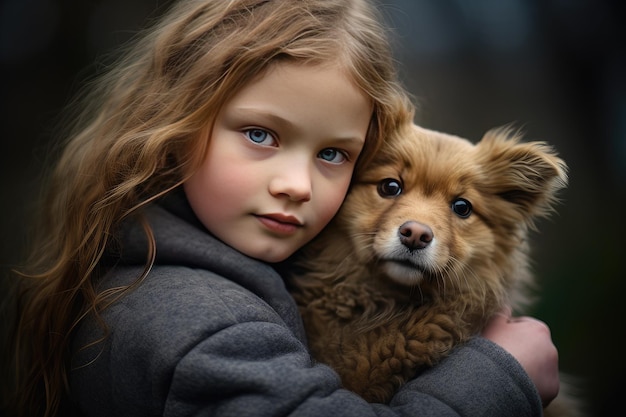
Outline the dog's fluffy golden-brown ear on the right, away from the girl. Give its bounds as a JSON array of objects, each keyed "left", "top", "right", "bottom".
[{"left": 476, "top": 128, "right": 567, "bottom": 223}]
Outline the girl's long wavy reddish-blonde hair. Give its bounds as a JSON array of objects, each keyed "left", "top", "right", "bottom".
[{"left": 4, "top": 0, "right": 413, "bottom": 417}]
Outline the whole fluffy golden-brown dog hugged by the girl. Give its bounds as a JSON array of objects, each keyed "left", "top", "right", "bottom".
[{"left": 289, "top": 122, "right": 567, "bottom": 412}]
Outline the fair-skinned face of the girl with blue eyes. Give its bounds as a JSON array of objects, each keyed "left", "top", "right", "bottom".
[{"left": 184, "top": 63, "right": 372, "bottom": 262}]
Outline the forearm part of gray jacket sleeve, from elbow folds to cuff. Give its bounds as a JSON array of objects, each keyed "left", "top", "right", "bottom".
[{"left": 164, "top": 322, "right": 541, "bottom": 417}]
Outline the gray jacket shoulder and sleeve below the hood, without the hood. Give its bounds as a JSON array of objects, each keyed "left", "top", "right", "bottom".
[{"left": 71, "top": 269, "right": 541, "bottom": 417}]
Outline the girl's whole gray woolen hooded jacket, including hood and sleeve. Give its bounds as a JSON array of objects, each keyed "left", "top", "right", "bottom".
[{"left": 70, "top": 193, "right": 542, "bottom": 417}]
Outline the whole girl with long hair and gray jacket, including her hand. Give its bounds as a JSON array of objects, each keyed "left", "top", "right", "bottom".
[{"left": 6, "top": 0, "right": 558, "bottom": 417}]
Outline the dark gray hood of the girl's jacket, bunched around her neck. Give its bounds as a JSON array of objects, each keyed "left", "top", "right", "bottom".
[{"left": 107, "top": 187, "right": 304, "bottom": 339}]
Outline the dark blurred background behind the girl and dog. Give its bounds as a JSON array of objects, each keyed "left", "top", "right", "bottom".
[{"left": 0, "top": 0, "right": 626, "bottom": 416}]
